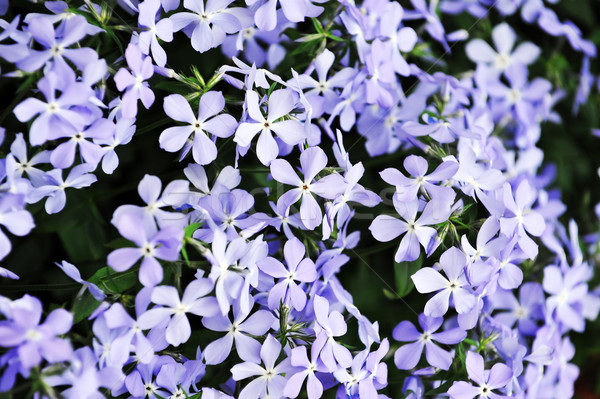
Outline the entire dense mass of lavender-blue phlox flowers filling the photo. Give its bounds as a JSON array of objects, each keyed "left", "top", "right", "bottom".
[{"left": 0, "top": 0, "right": 600, "bottom": 399}]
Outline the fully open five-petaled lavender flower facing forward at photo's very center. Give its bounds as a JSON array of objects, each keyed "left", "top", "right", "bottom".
[{"left": 271, "top": 147, "right": 345, "bottom": 230}]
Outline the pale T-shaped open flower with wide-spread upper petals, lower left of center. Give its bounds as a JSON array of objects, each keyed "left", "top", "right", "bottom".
[{"left": 138, "top": 278, "right": 219, "bottom": 346}]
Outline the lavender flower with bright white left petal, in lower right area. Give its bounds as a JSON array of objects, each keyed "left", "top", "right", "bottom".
[{"left": 411, "top": 247, "right": 475, "bottom": 317}]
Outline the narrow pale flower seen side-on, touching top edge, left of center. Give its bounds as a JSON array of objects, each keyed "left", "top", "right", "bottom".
[{"left": 138, "top": 0, "right": 173, "bottom": 67}]
